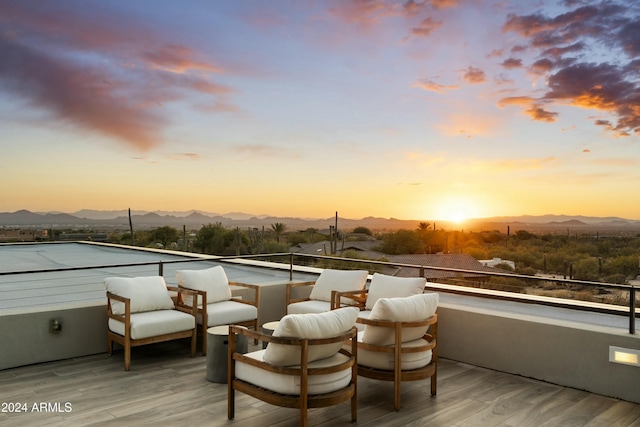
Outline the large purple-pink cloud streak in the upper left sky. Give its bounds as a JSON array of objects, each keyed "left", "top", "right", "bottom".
[{"left": 0, "top": 1, "right": 233, "bottom": 150}]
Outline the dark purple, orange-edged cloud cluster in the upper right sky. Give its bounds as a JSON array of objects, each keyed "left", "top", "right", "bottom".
[{"left": 499, "top": 1, "right": 640, "bottom": 136}]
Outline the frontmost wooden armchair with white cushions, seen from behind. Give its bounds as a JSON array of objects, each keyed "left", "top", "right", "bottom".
[{"left": 228, "top": 307, "right": 358, "bottom": 426}]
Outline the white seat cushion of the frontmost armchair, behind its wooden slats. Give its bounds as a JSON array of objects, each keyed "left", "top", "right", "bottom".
[{"left": 236, "top": 350, "right": 351, "bottom": 395}]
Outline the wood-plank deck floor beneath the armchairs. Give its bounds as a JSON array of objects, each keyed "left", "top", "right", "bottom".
[{"left": 0, "top": 343, "right": 640, "bottom": 427}]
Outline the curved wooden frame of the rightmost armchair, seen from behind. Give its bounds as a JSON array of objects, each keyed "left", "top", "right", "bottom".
[{"left": 357, "top": 314, "right": 438, "bottom": 411}]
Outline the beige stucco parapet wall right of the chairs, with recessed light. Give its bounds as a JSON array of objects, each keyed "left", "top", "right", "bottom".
[{"left": 438, "top": 293, "right": 640, "bottom": 403}]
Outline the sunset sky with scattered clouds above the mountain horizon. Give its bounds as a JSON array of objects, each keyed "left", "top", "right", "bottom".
[{"left": 0, "top": 0, "right": 640, "bottom": 220}]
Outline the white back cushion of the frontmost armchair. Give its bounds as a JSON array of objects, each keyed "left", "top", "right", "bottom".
[{"left": 264, "top": 307, "right": 359, "bottom": 366}]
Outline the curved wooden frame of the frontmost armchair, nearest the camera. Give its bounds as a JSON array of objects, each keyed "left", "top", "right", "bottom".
[{"left": 227, "top": 325, "right": 358, "bottom": 426}]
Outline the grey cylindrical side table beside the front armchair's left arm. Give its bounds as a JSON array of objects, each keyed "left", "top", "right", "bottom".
[{"left": 206, "top": 325, "right": 247, "bottom": 383}]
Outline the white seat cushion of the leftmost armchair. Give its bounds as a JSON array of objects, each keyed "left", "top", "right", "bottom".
[{"left": 109, "top": 310, "right": 196, "bottom": 340}]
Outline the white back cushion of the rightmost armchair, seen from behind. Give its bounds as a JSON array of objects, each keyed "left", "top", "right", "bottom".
[{"left": 362, "top": 293, "right": 439, "bottom": 345}]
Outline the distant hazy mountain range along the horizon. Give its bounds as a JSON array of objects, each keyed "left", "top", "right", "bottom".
[{"left": 0, "top": 209, "right": 640, "bottom": 232}]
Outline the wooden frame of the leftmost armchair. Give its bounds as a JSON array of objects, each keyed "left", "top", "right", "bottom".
[{"left": 107, "top": 286, "right": 198, "bottom": 371}]
